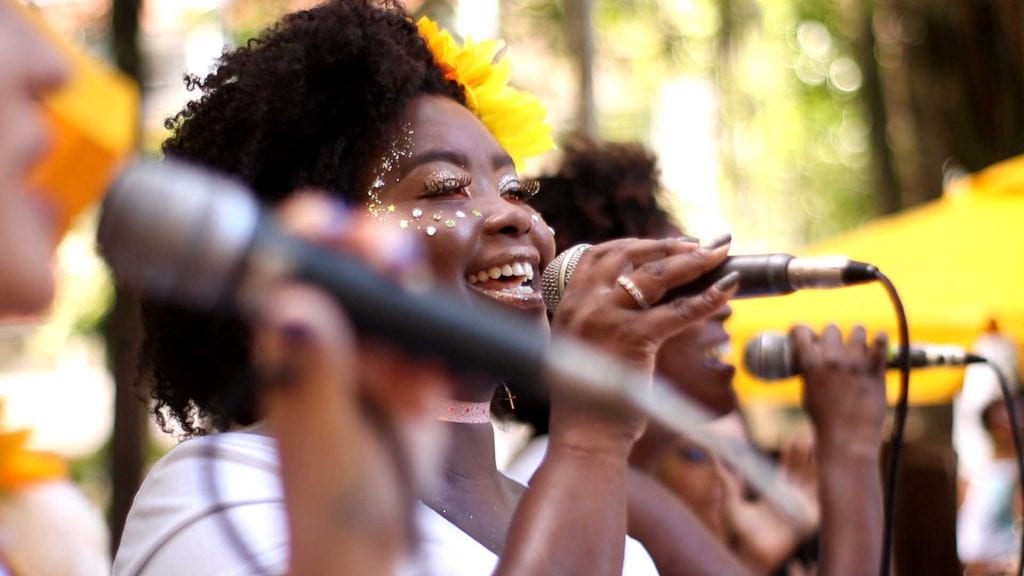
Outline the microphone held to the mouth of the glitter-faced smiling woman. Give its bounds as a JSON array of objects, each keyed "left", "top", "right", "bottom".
[{"left": 541, "top": 244, "right": 879, "bottom": 312}]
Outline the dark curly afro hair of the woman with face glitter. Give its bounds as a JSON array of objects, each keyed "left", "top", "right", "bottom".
[{"left": 140, "top": 0, "right": 465, "bottom": 436}]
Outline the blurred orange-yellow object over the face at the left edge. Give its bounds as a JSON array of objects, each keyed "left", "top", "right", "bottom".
[{"left": 13, "top": 2, "right": 139, "bottom": 235}]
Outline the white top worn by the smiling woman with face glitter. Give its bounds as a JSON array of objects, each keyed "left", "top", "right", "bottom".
[{"left": 114, "top": 431, "right": 657, "bottom": 576}]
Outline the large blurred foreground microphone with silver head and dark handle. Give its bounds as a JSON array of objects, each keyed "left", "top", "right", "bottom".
[{"left": 97, "top": 161, "right": 550, "bottom": 385}]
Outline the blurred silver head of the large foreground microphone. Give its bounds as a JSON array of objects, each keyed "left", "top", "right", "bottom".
[{"left": 96, "top": 160, "right": 260, "bottom": 306}]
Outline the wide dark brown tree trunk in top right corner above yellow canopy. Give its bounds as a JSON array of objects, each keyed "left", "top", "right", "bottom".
[{"left": 874, "top": 0, "right": 1024, "bottom": 206}]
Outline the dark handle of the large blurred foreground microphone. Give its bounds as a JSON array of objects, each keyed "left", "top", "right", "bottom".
[{"left": 264, "top": 227, "right": 547, "bottom": 386}]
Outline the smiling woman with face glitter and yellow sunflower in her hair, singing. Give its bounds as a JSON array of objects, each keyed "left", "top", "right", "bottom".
[{"left": 115, "top": 0, "right": 761, "bottom": 574}]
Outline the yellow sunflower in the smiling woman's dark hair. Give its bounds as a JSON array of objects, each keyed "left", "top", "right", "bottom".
[{"left": 416, "top": 16, "right": 555, "bottom": 167}]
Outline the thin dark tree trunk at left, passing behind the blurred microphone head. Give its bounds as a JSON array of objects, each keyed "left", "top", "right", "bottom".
[{"left": 103, "top": 0, "right": 146, "bottom": 551}]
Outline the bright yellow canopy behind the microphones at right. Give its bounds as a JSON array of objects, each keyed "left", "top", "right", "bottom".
[{"left": 729, "top": 156, "right": 1024, "bottom": 404}]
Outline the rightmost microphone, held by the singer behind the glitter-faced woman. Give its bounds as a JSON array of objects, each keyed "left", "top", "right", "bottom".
[{"left": 743, "top": 332, "right": 985, "bottom": 380}]
